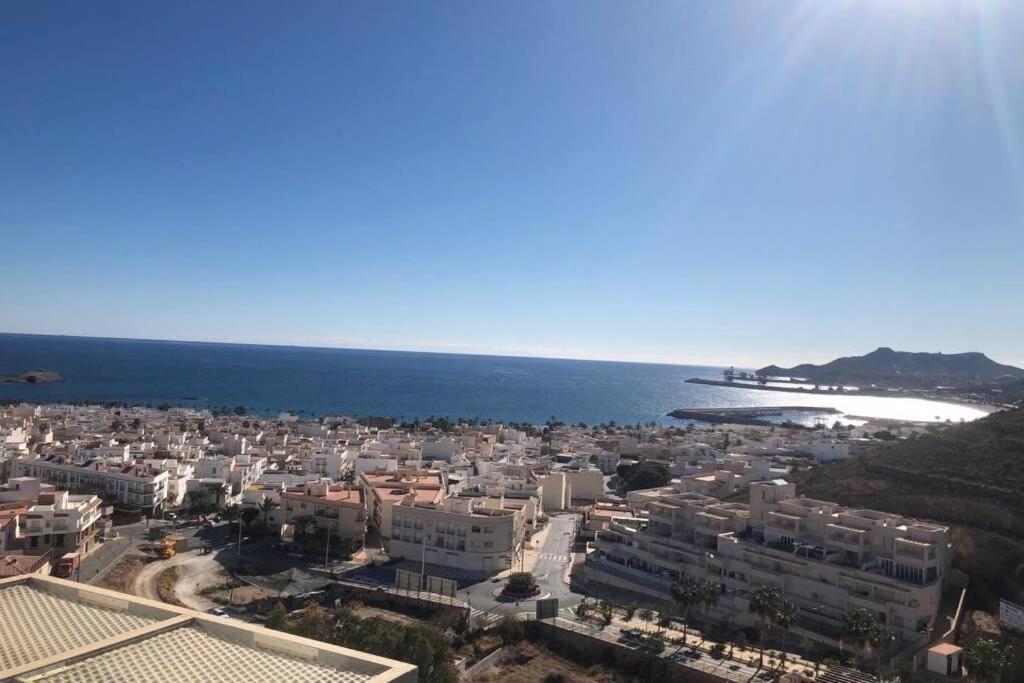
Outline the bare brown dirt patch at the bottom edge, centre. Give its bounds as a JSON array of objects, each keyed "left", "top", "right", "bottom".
[{"left": 470, "top": 642, "right": 630, "bottom": 683}]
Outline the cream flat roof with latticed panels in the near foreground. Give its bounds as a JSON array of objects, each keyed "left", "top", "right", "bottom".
[{"left": 0, "top": 574, "right": 417, "bottom": 683}]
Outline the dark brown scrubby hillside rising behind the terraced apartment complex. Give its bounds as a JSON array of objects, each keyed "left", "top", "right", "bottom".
[{"left": 796, "top": 409, "right": 1024, "bottom": 609}]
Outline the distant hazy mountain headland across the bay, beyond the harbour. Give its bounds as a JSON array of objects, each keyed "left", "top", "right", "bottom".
[{"left": 758, "top": 346, "right": 1024, "bottom": 388}]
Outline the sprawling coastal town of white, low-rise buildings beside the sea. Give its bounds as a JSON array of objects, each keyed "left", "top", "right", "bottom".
[{"left": 0, "top": 403, "right": 1012, "bottom": 681}]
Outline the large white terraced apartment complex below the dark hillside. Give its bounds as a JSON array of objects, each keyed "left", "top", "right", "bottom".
[{"left": 587, "top": 480, "right": 950, "bottom": 646}]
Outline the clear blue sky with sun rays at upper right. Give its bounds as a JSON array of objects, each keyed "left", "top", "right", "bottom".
[{"left": 0, "top": 0, "right": 1024, "bottom": 365}]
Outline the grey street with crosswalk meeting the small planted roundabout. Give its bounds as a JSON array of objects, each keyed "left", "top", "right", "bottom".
[{"left": 458, "top": 514, "right": 583, "bottom": 621}]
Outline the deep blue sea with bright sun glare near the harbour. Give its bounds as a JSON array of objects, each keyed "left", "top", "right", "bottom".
[{"left": 0, "top": 334, "right": 984, "bottom": 425}]
